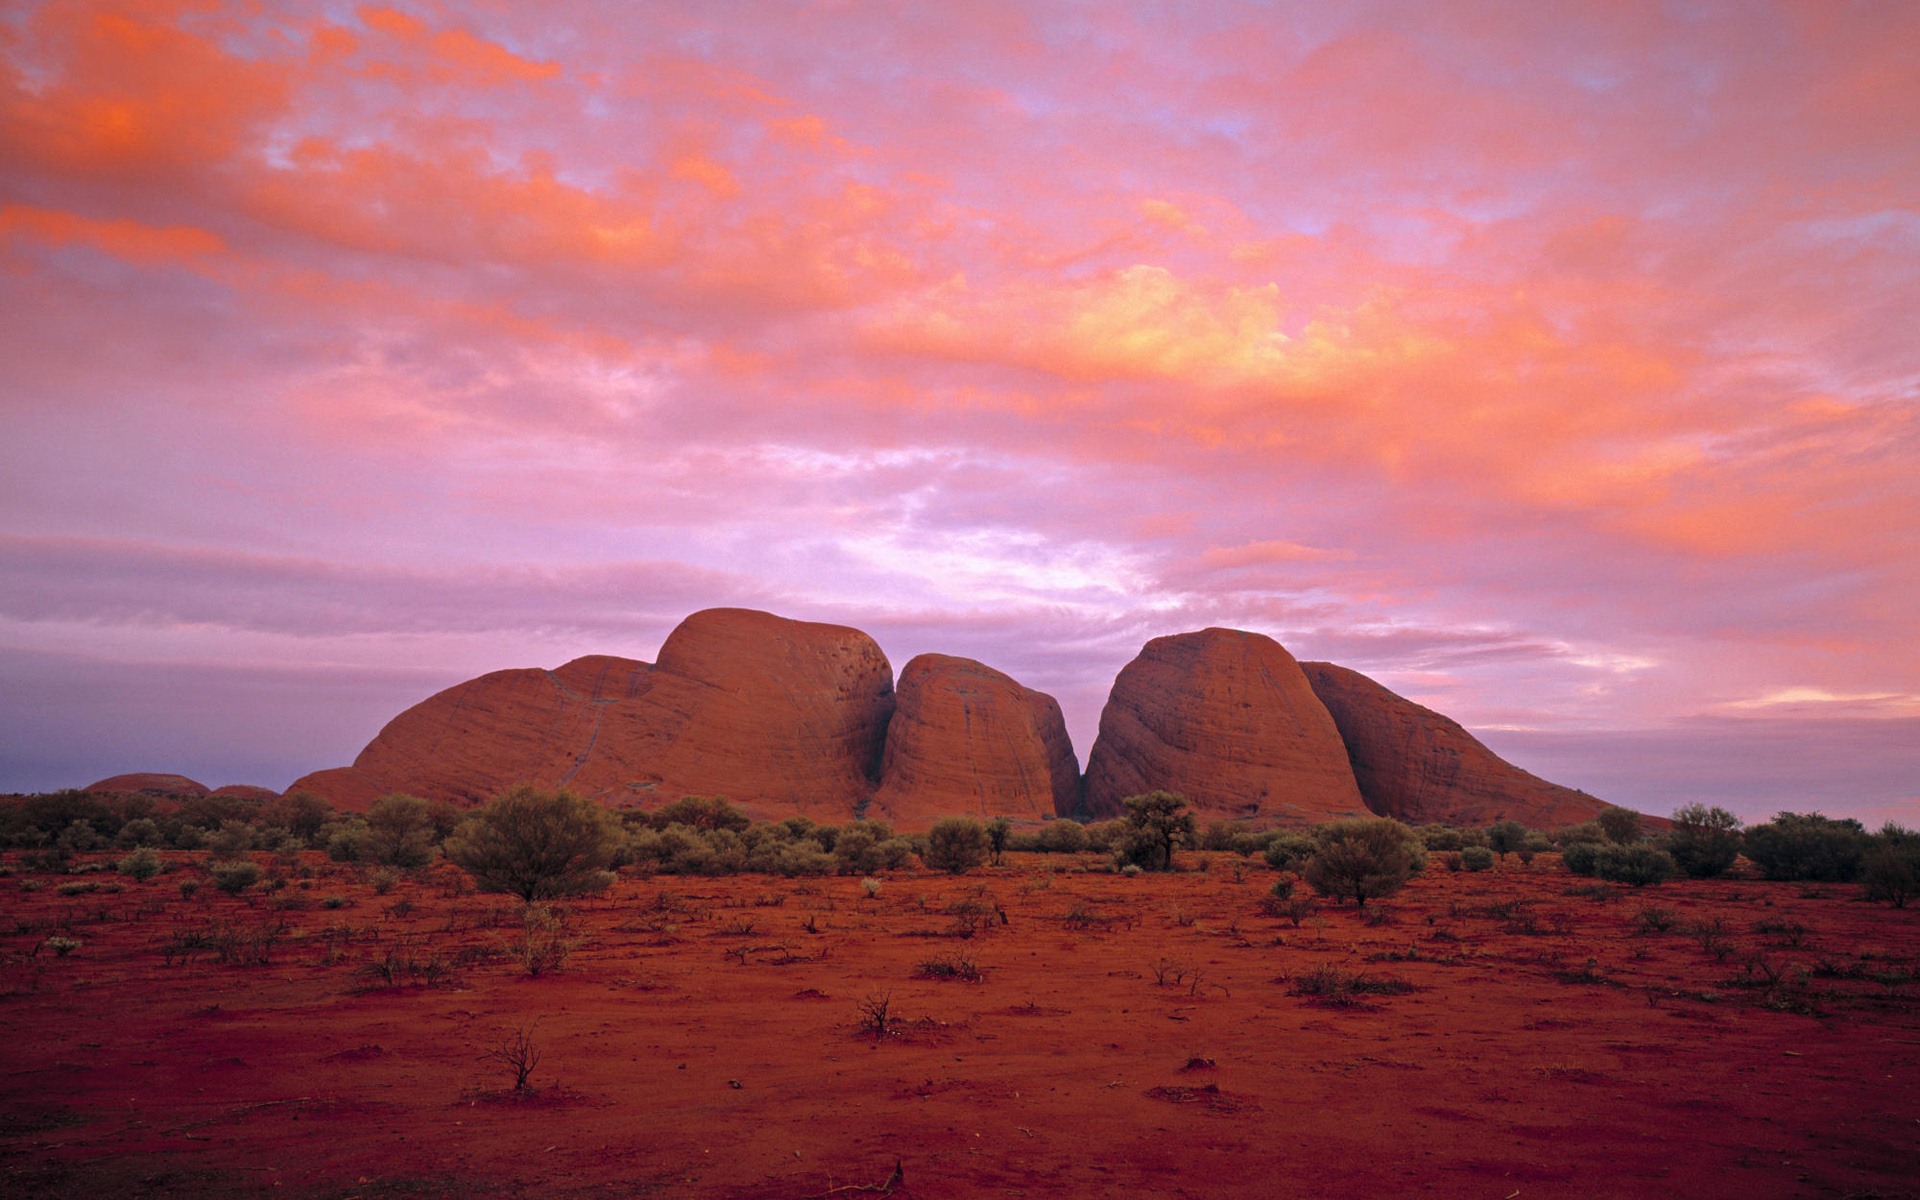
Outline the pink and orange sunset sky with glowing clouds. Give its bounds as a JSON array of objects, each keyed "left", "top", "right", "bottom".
[{"left": 0, "top": 0, "right": 1920, "bottom": 824}]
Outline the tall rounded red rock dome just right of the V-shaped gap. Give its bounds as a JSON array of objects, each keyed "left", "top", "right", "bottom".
[{"left": 1085, "top": 630, "right": 1367, "bottom": 824}]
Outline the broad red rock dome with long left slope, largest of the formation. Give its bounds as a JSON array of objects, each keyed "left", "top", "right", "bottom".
[{"left": 292, "top": 609, "right": 893, "bottom": 820}]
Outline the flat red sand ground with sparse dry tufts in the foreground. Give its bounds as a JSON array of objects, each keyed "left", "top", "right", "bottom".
[{"left": 0, "top": 854, "right": 1920, "bottom": 1200}]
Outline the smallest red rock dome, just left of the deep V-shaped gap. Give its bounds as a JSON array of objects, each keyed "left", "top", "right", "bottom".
[{"left": 870, "top": 655, "right": 1079, "bottom": 829}]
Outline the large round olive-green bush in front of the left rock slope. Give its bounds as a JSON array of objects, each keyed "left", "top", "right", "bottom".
[{"left": 442, "top": 785, "right": 622, "bottom": 902}]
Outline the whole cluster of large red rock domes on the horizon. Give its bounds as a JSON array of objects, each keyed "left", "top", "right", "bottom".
[{"left": 240, "top": 609, "right": 1605, "bottom": 829}]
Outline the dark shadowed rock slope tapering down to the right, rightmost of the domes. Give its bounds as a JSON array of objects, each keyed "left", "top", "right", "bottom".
[{"left": 1300, "top": 662, "right": 1605, "bottom": 829}]
